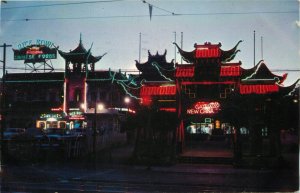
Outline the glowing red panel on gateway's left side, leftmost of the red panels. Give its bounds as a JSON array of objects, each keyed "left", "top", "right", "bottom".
[{"left": 140, "top": 85, "right": 176, "bottom": 96}]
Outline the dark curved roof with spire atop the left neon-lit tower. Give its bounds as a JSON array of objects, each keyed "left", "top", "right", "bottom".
[{"left": 58, "top": 36, "right": 106, "bottom": 64}]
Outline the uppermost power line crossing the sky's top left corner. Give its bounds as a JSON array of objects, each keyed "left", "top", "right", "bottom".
[{"left": 2, "top": 0, "right": 123, "bottom": 10}]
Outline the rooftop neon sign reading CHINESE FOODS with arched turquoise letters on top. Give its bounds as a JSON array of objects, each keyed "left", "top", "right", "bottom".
[{"left": 13, "top": 39, "right": 57, "bottom": 63}]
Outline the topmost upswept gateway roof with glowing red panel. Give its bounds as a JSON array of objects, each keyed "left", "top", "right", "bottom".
[{"left": 174, "top": 40, "right": 242, "bottom": 63}]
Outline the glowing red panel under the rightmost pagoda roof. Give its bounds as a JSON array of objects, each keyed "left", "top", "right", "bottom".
[{"left": 240, "top": 84, "right": 279, "bottom": 94}]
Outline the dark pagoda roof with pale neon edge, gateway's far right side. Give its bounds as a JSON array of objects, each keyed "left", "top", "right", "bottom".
[{"left": 241, "top": 60, "right": 287, "bottom": 84}]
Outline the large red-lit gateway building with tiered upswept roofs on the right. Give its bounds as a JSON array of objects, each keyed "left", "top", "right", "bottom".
[{"left": 137, "top": 41, "right": 299, "bottom": 163}]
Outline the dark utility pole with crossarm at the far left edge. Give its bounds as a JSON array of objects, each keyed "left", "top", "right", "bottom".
[{"left": 0, "top": 43, "right": 12, "bottom": 171}]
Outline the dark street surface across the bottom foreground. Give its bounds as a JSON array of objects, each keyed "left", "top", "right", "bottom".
[{"left": 1, "top": 146, "right": 299, "bottom": 193}]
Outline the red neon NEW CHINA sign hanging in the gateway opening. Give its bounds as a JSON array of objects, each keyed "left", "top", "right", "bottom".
[{"left": 187, "top": 102, "right": 220, "bottom": 115}]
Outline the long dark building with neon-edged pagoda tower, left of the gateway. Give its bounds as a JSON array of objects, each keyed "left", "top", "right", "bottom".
[{"left": 4, "top": 38, "right": 134, "bottom": 129}]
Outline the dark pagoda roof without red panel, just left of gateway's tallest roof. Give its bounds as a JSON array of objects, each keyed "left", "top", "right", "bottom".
[{"left": 135, "top": 50, "right": 175, "bottom": 81}]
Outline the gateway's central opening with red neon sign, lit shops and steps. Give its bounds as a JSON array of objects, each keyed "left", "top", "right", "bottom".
[{"left": 181, "top": 101, "right": 235, "bottom": 162}]
